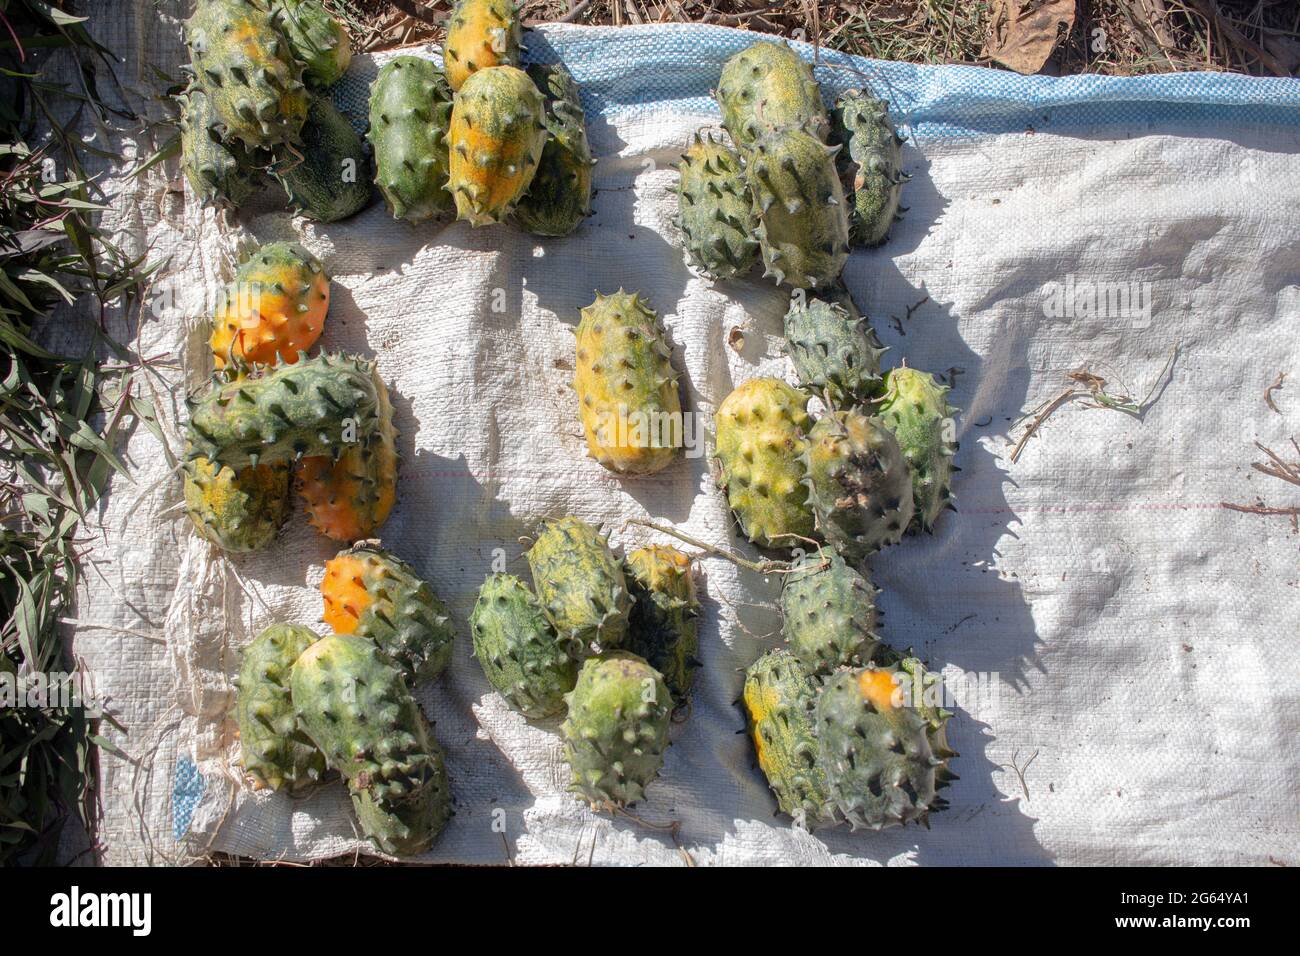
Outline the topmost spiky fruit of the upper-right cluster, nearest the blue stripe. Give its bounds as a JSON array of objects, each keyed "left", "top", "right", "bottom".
[{"left": 715, "top": 40, "right": 831, "bottom": 152}]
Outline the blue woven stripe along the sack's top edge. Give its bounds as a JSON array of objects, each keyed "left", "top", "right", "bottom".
[{"left": 527, "top": 23, "right": 1300, "bottom": 139}]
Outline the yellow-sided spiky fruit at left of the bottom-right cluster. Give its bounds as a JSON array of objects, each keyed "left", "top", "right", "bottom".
[{"left": 741, "top": 648, "right": 836, "bottom": 830}]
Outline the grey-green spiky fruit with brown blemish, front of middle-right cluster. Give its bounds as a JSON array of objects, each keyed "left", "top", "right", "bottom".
[{"left": 803, "top": 410, "right": 914, "bottom": 564}]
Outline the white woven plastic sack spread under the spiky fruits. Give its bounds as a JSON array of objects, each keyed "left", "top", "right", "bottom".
[{"left": 75, "top": 3, "right": 1300, "bottom": 864}]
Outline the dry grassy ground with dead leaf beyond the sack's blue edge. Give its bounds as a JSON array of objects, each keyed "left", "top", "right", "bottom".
[{"left": 326, "top": 0, "right": 1300, "bottom": 77}]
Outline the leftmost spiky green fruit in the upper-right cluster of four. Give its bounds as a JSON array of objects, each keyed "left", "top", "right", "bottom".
[{"left": 677, "top": 133, "right": 758, "bottom": 278}]
